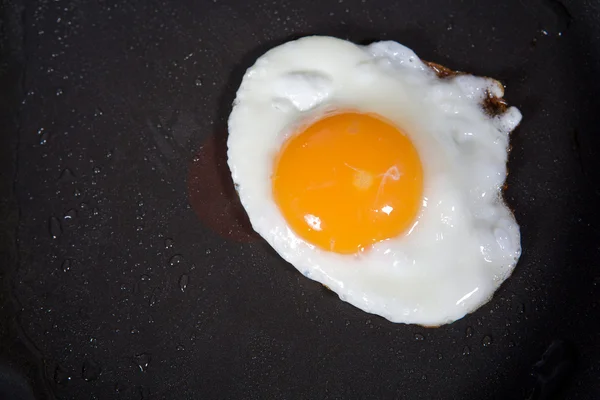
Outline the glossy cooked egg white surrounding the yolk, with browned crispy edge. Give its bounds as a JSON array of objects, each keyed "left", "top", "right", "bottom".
[{"left": 228, "top": 36, "right": 521, "bottom": 326}]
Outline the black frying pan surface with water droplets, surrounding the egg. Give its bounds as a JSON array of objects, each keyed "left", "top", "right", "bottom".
[{"left": 0, "top": 0, "right": 600, "bottom": 399}]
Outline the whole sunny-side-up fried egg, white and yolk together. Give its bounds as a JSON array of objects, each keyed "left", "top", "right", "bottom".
[{"left": 228, "top": 36, "right": 521, "bottom": 326}]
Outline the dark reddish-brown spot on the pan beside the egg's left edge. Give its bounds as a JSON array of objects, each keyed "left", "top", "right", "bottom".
[{"left": 188, "top": 135, "right": 258, "bottom": 243}]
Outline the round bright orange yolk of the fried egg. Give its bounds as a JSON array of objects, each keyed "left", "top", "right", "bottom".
[{"left": 272, "top": 112, "right": 423, "bottom": 254}]
